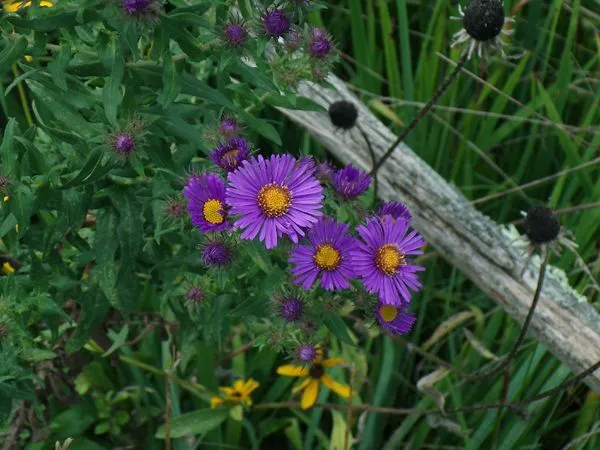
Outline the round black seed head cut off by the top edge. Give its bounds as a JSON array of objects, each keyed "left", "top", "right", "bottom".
[{"left": 463, "top": 0, "right": 504, "bottom": 42}]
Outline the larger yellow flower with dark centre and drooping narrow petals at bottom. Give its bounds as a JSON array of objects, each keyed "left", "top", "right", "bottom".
[{"left": 277, "top": 355, "right": 351, "bottom": 409}]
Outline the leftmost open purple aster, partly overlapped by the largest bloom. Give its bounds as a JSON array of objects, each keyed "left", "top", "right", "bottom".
[{"left": 183, "top": 173, "right": 231, "bottom": 233}]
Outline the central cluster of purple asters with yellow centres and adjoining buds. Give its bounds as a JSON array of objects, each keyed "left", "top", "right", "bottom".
[{"left": 183, "top": 123, "right": 425, "bottom": 334}]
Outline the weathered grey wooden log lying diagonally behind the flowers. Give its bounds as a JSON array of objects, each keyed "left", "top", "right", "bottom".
[{"left": 281, "top": 76, "right": 600, "bottom": 392}]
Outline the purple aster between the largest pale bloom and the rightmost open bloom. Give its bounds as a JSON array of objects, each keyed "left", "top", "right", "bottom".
[{"left": 289, "top": 217, "right": 357, "bottom": 291}]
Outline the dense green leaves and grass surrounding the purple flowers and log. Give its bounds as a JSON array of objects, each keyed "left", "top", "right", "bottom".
[{"left": 0, "top": 0, "right": 600, "bottom": 450}]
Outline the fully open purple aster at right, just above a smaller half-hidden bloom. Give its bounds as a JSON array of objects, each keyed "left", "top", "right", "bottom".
[{"left": 353, "top": 215, "right": 425, "bottom": 306}]
